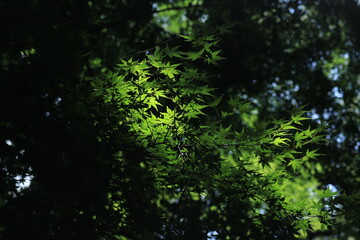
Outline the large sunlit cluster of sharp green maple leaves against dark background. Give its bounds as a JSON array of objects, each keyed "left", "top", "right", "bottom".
[{"left": 96, "top": 29, "right": 336, "bottom": 239}]
